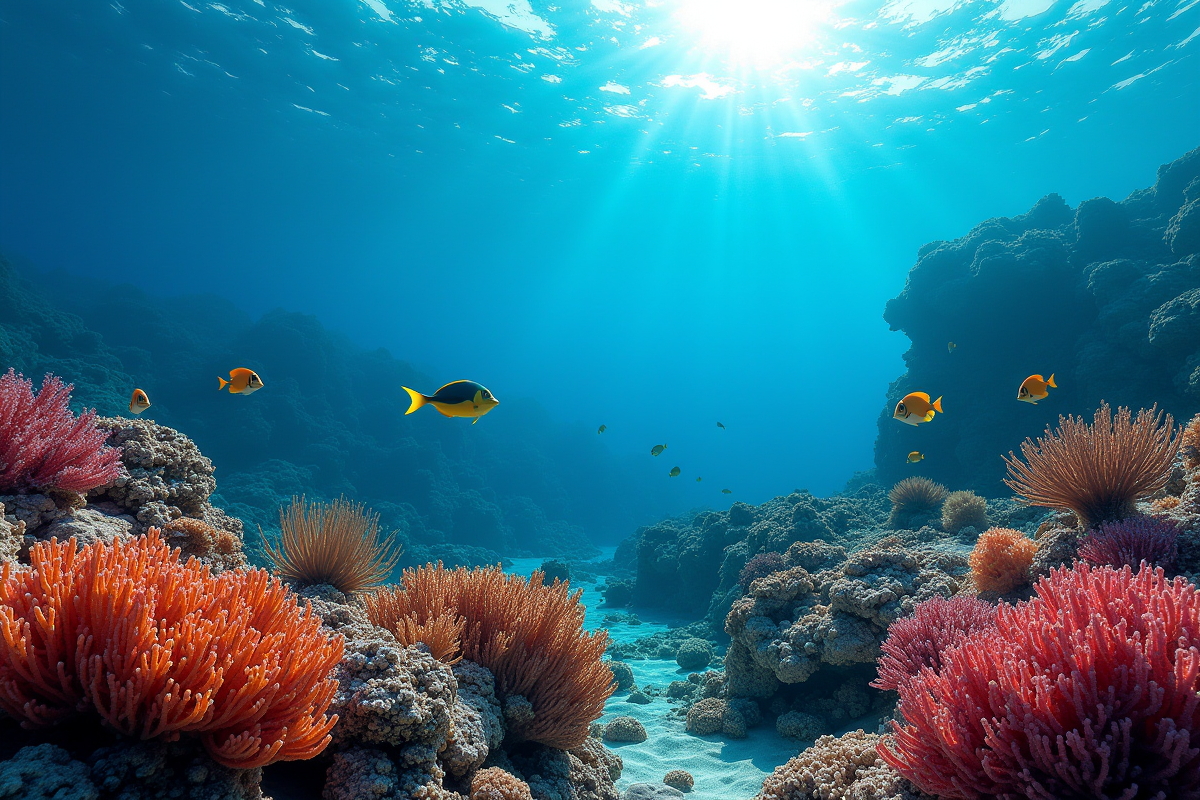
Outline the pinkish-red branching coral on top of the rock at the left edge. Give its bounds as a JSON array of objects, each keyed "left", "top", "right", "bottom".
[{"left": 0, "top": 369, "right": 121, "bottom": 493}]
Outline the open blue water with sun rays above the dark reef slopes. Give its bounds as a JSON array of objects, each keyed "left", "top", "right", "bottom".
[{"left": 0, "top": 0, "right": 1200, "bottom": 512}]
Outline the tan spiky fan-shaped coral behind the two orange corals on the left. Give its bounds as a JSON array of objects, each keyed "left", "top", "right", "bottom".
[{"left": 259, "top": 497, "right": 403, "bottom": 595}]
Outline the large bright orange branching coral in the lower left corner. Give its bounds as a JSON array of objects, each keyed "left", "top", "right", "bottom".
[{"left": 0, "top": 528, "right": 342, "bottom": 769}]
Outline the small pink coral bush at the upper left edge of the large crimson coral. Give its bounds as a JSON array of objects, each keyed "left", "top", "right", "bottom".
[{"left": 871, "top": 595, "right": 996, "bottom": 691}]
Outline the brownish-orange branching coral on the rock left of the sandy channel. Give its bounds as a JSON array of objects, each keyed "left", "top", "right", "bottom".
[{"left": 364, "top": 563, "right": 616, "bottom": 750}]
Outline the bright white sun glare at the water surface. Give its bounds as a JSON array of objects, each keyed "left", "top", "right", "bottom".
[{"left": 676, "top": 0, "right": 834, "bottom": 66}]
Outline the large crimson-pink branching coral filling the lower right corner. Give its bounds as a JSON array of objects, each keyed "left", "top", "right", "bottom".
[{"left": 880, "top": 561, "right": 1200, "bottom": 800}]
